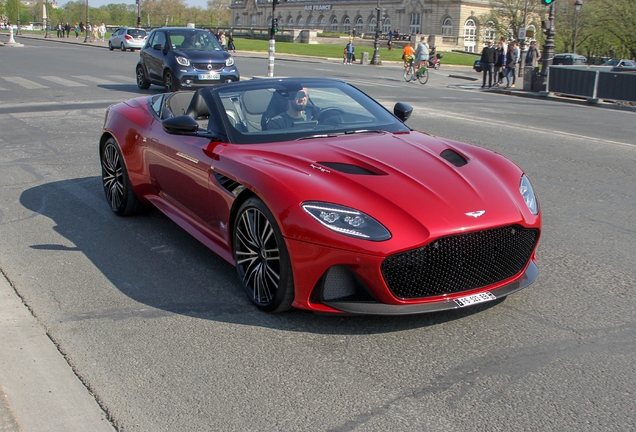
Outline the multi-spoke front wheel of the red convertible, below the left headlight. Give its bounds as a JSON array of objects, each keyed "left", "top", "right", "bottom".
[{"left": 232, "top": 197, "right": 294, "bottom": 313}]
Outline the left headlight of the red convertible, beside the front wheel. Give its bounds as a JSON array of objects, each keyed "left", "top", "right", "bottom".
[{"left": 302, "top": 201, "right": 391, "bottom": 241}]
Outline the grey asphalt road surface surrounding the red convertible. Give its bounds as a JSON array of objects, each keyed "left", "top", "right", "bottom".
[{"left": 0, "top": 37, "right": 636, "bottom": 431}]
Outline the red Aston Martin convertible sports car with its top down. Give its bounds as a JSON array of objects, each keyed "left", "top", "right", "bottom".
[{"left": 99, "top": 78, "right": 541, "bottom": 314}]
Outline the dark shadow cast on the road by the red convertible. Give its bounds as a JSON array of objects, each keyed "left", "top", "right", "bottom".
[{"left": 20, "top": 177, "right": 503, "bottom": 334}]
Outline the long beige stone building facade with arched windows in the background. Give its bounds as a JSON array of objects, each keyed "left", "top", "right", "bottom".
[{"left": 230, "top": 0, "right": 534, "bottom": 52}]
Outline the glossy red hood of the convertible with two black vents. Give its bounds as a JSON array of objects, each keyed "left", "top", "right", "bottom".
[{"left": 229, "top": 132, "right": 534, "bottom": 243}]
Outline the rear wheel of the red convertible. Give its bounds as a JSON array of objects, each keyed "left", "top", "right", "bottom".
[{"left": 99, "top": 137, "right": 143, "bottom": 216}]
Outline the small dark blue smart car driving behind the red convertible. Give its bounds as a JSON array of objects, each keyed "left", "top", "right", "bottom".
[{"left": 135, "top": 27, "right": 240, "bottom": 92}]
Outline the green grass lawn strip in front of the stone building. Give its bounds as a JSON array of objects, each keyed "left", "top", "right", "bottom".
[{"left": 234, "top": 38, "right": 477, "bottom": 66}]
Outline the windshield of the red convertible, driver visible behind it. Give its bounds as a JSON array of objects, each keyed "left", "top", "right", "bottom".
[{"left": 215, "top": 79, "right": 410, "bottom": 144}]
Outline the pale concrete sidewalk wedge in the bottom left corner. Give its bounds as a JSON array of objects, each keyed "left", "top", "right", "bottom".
[{"left": 0, "top": 273, "right": 115, "bottom": 432}]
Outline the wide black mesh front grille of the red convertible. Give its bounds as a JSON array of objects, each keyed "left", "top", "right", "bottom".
[{"left": 382, "top": 225, "right": 539, "bottom": 299}]
